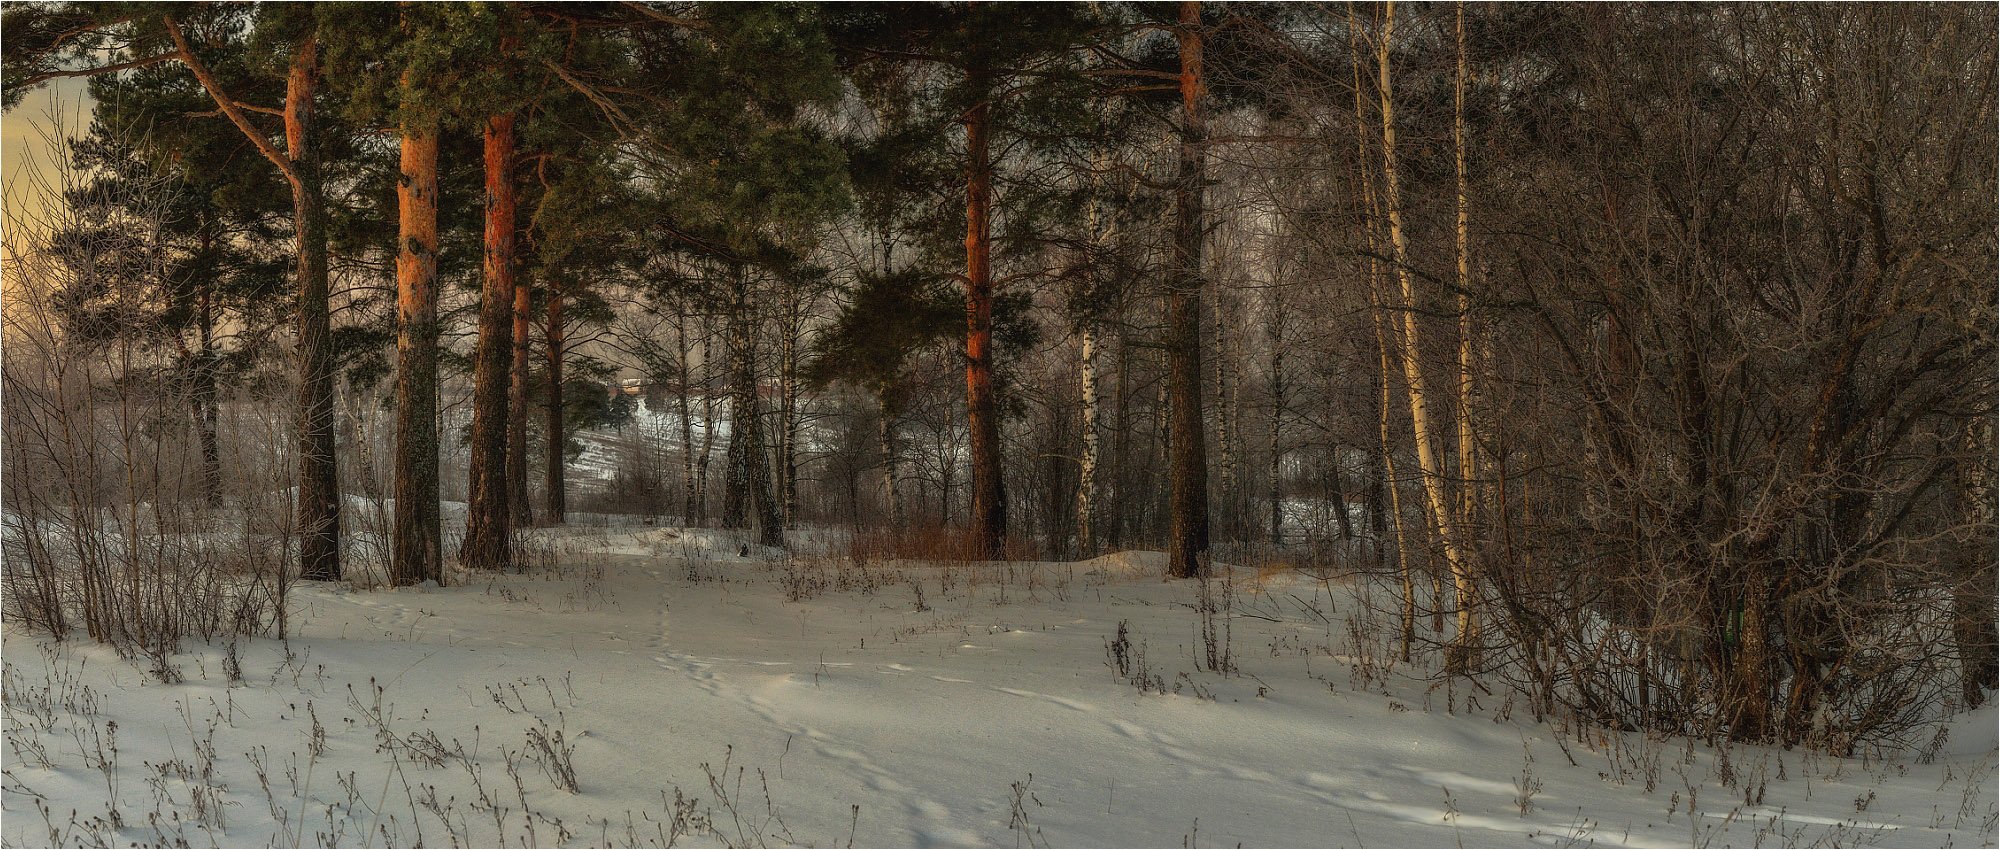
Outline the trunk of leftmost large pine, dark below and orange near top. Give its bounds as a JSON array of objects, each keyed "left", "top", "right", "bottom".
[{"left": 284, "top": 36, "right": 340, "bottom": 582}]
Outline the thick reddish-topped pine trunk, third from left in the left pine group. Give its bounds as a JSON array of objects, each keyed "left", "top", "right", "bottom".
[{"left": 458, "top": 107, "right": 514, "bottom": 570}]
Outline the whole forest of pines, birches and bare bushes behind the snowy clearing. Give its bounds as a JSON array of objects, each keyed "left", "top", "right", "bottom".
[{"left": 4, "top": 2, "right": 2000, "bottom": 748}]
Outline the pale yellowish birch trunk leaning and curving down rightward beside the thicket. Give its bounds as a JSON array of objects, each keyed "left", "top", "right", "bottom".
[{"left": 1376, "top": 0, "right": 1478, "bottom": 670}]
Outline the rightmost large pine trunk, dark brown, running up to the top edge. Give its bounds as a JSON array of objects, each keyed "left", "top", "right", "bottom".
[{"left": 1166, "top": 0, "right": 1208, "bottom": 578}]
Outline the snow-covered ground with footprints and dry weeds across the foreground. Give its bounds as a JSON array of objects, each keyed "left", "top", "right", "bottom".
[{"left": 0, "top": 526, "right": 2000, "bottom": 846}]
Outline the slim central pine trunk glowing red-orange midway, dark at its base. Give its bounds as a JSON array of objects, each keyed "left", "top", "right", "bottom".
[{"left": 962, "top": 76, "right": 1006, "bottom": 558}]
